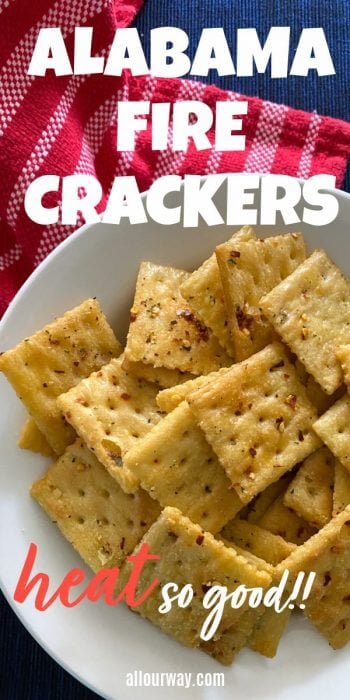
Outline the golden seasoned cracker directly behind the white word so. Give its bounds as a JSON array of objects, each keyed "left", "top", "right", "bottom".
[{"left": 118, "top": 508, "right": 271, "bottom": 647}]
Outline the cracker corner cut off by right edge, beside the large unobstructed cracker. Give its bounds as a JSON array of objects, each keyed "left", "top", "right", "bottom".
[{"left": 314, "top": 394, "right": 350, "bottom": 471}]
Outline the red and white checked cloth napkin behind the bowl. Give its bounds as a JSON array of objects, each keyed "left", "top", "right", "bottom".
[{"left": 0, "top": 0, "right": 350, "bottom": 314}]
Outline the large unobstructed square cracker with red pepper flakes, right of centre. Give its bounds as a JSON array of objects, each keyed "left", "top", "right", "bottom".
[{"left": 187, "top": 343, "right": 320, "bottom": 503}]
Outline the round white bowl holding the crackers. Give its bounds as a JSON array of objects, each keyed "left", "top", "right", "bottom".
[{"left": 0, "top": 176, "right": 350, "bottom": 700}]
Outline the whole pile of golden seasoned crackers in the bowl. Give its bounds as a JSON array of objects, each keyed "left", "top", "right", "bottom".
[{"left": 0, "top": 227, "right": 350, "bottom": 664}]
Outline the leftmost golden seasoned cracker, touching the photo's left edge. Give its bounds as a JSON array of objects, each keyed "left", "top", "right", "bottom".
[{"left": 0, "top": 299, "right": 121, "bottom": 454}]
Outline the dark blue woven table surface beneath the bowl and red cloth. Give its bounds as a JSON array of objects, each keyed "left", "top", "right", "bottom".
[{"left": 0, "top": 0, "right": 350, "bottom": 700}]
